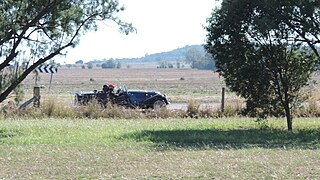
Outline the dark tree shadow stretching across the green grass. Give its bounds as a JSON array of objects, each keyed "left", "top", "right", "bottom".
[{"left": 122, "top": 129, "right": 320, "bottom": 150}]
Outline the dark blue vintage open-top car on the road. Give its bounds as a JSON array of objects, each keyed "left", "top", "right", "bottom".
[{"left": 75, "top": 87, "right": 169, "bottom": 109}]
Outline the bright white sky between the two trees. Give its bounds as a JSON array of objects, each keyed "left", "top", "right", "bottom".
[{"left": 56, "top": 0, "right": 218, "bottom": 63}]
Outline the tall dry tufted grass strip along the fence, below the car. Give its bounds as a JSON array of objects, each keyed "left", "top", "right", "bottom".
[{"left": 0, "top": 96, "right": 241, "bottom": 119}]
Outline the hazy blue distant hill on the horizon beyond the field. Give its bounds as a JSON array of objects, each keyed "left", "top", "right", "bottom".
[{"left": 91, "top": 45, "right": 205, "bottom": 64}]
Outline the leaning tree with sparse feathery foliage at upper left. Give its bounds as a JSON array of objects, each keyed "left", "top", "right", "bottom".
[{"left": 0, "top": 0, "right": 134, "bottom": 102}]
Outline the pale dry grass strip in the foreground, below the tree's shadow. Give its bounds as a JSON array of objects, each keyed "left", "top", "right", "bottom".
[{"left": 0, "top": 145, "right": 320, "bottom": 179}]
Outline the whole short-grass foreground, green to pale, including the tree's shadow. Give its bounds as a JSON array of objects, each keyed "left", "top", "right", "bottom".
[{"left": 0, "top": 118, "right": 320, "bottom": 179}]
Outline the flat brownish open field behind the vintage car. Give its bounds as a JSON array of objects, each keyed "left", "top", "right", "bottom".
[{"left": 23, "top": 67, "right": 228, "bottom": 102}]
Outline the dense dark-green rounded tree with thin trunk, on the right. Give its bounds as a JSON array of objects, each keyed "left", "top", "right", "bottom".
[{"left": 205, "top": 0, "right": 320, "bottom": 130}]
